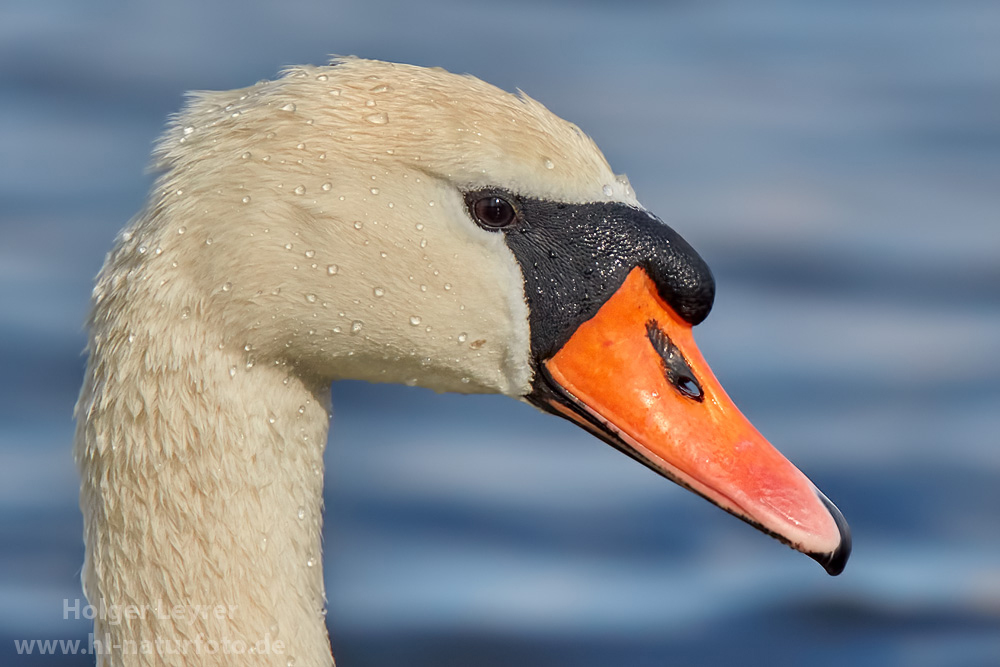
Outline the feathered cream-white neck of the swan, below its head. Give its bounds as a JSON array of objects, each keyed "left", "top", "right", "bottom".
[{"left": 76, "top": 311, "right": 333, "bottom": 667}]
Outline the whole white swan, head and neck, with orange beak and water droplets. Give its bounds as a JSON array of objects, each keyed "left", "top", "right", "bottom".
[{"left": 74, "top": 58, "right": 850, "bottom": 667}]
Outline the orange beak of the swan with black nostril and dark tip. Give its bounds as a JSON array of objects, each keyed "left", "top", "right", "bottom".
[{"left": 542, "top": 268, "right": 851, "bottom": 575}]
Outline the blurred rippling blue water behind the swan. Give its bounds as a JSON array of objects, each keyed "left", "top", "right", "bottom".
[{"left": 0, "top": 0, "right": 1000, "bottom": 667}]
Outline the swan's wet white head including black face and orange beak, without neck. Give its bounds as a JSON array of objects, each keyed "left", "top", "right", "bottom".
[{"left": 107, "top": 59, "right": 850, "bottom": 574}]
